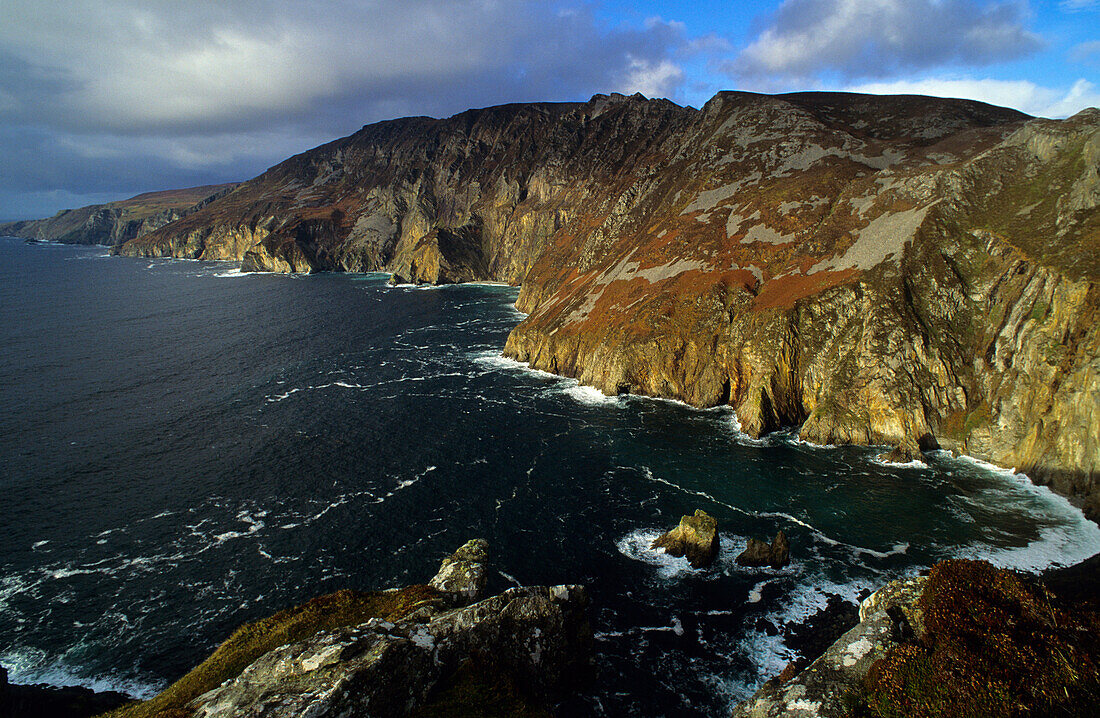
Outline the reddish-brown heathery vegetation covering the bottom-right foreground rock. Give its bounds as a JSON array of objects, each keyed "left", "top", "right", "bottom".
[{"left": 853, "top": 561, "right": 1100, "bottom": 718}]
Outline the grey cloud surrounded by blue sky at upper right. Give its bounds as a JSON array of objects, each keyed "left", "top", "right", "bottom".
[{"left": 723, "top": 0, "right": 1042, "bottom": 81}]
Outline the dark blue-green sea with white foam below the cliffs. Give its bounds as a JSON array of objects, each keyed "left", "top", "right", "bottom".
[{"left": 0, "top": 239, "right": 1100, "bottom": 716}]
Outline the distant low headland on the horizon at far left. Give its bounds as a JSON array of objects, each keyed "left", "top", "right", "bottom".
[{"left": 0, "top": 183, "right": 237, "bottom": 245}]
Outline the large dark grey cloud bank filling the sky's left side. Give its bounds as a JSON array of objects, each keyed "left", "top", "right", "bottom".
[{"left": 0, "top": 0, "right": 699, "bottom": 216}]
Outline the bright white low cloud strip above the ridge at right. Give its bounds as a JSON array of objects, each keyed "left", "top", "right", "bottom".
[{"left": 845, "top": 78, "right": 1100, "bottom": 118}]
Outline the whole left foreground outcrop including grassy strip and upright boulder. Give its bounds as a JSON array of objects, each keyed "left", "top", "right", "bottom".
[{"left": 105, "top": 539, "right": 593, "bottom": 718}]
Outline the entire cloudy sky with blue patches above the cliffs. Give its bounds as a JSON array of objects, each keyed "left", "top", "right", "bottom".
[{"left": 0, "top": 0, "right": 1100, "bottom": 219}]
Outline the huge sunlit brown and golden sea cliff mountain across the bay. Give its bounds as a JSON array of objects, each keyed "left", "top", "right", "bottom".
[{"left": 114, "top": 92, "right": 1100, "bottom": 518}]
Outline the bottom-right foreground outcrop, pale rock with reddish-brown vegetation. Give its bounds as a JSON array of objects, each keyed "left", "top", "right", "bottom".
[{"left": 733, "top": 560, "right": 1100, "bottom": 718}]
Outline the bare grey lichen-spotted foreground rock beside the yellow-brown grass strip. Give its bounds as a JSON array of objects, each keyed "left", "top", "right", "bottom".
[{"left": 187, "top": 580, "right": 592, "bottom": 718}]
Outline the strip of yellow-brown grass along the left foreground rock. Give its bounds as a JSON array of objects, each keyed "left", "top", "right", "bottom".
[{"left": 107, "top": 586, "right": 439, "bottom": 718}]
